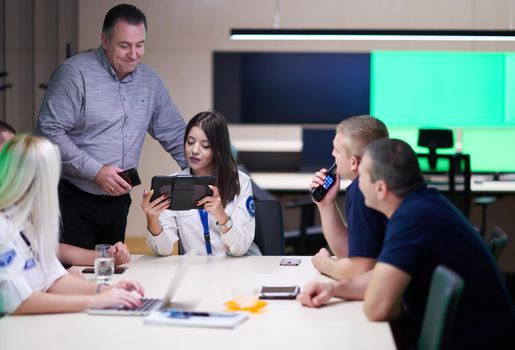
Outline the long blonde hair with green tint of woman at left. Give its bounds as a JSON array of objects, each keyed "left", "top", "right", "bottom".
[{"left": 0, "top": 135, "right": 61, "bottom": 267}]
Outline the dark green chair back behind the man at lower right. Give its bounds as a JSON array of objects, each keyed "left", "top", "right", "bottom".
[{"left": 418, "top": 265, "right": 464, "bottom": 350}]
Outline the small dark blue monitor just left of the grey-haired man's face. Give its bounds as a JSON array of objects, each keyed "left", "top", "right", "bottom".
[{"left": 300, "top": 128, "right": 336, "bottom": 172}]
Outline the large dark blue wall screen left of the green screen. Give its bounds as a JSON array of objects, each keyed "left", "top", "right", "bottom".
[{"left": 214, "top": 52, "right": 370, "bottom": 124}]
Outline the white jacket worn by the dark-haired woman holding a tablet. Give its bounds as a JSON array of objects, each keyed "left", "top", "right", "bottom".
[{"left": 147, "top": 168, "right": 256, "bottom": 256}]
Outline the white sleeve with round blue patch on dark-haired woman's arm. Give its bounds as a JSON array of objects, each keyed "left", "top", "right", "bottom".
[{"left": 222, "top": 172, "right": 256, "bottom": 256}]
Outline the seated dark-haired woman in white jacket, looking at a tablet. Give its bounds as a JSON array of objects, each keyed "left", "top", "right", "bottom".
[{"left": 141, "top": 112, "right": 261, "bottom": 256}]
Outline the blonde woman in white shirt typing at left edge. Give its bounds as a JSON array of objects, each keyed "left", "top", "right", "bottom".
[{"left": 0, "top": 135, "right": 143, "bottom": 314}]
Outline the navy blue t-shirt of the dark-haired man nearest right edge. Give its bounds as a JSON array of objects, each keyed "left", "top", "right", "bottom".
[{"left": 378, "top": 184, "right": 515, "bottom": 349}]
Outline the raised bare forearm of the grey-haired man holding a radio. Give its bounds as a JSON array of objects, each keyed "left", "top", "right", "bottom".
[{"left": 319, "top": 202, "right": 348, "bottom": 258}]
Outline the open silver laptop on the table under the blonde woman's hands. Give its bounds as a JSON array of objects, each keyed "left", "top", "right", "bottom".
[{"left": 87, "top": 254, "right": 193, "bottom": 316}]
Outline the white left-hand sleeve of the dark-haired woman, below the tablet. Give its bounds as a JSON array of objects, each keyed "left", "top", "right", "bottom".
[{"left": 147, "top": 209, "right": 179, "bottom": 256}]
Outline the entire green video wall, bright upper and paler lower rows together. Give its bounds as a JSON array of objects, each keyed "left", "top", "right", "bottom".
[{"left": 370, "top": 51, "right": 515, "bottom": 172}]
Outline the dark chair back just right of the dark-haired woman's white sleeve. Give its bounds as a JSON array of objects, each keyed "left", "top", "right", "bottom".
[{"left": 254, "top": 200, "right": 284, "bottom": 255}]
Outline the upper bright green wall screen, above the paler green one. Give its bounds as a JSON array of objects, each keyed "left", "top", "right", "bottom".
[{"left": 370, "top": 51, "right": 515, "bottom": 127}]
